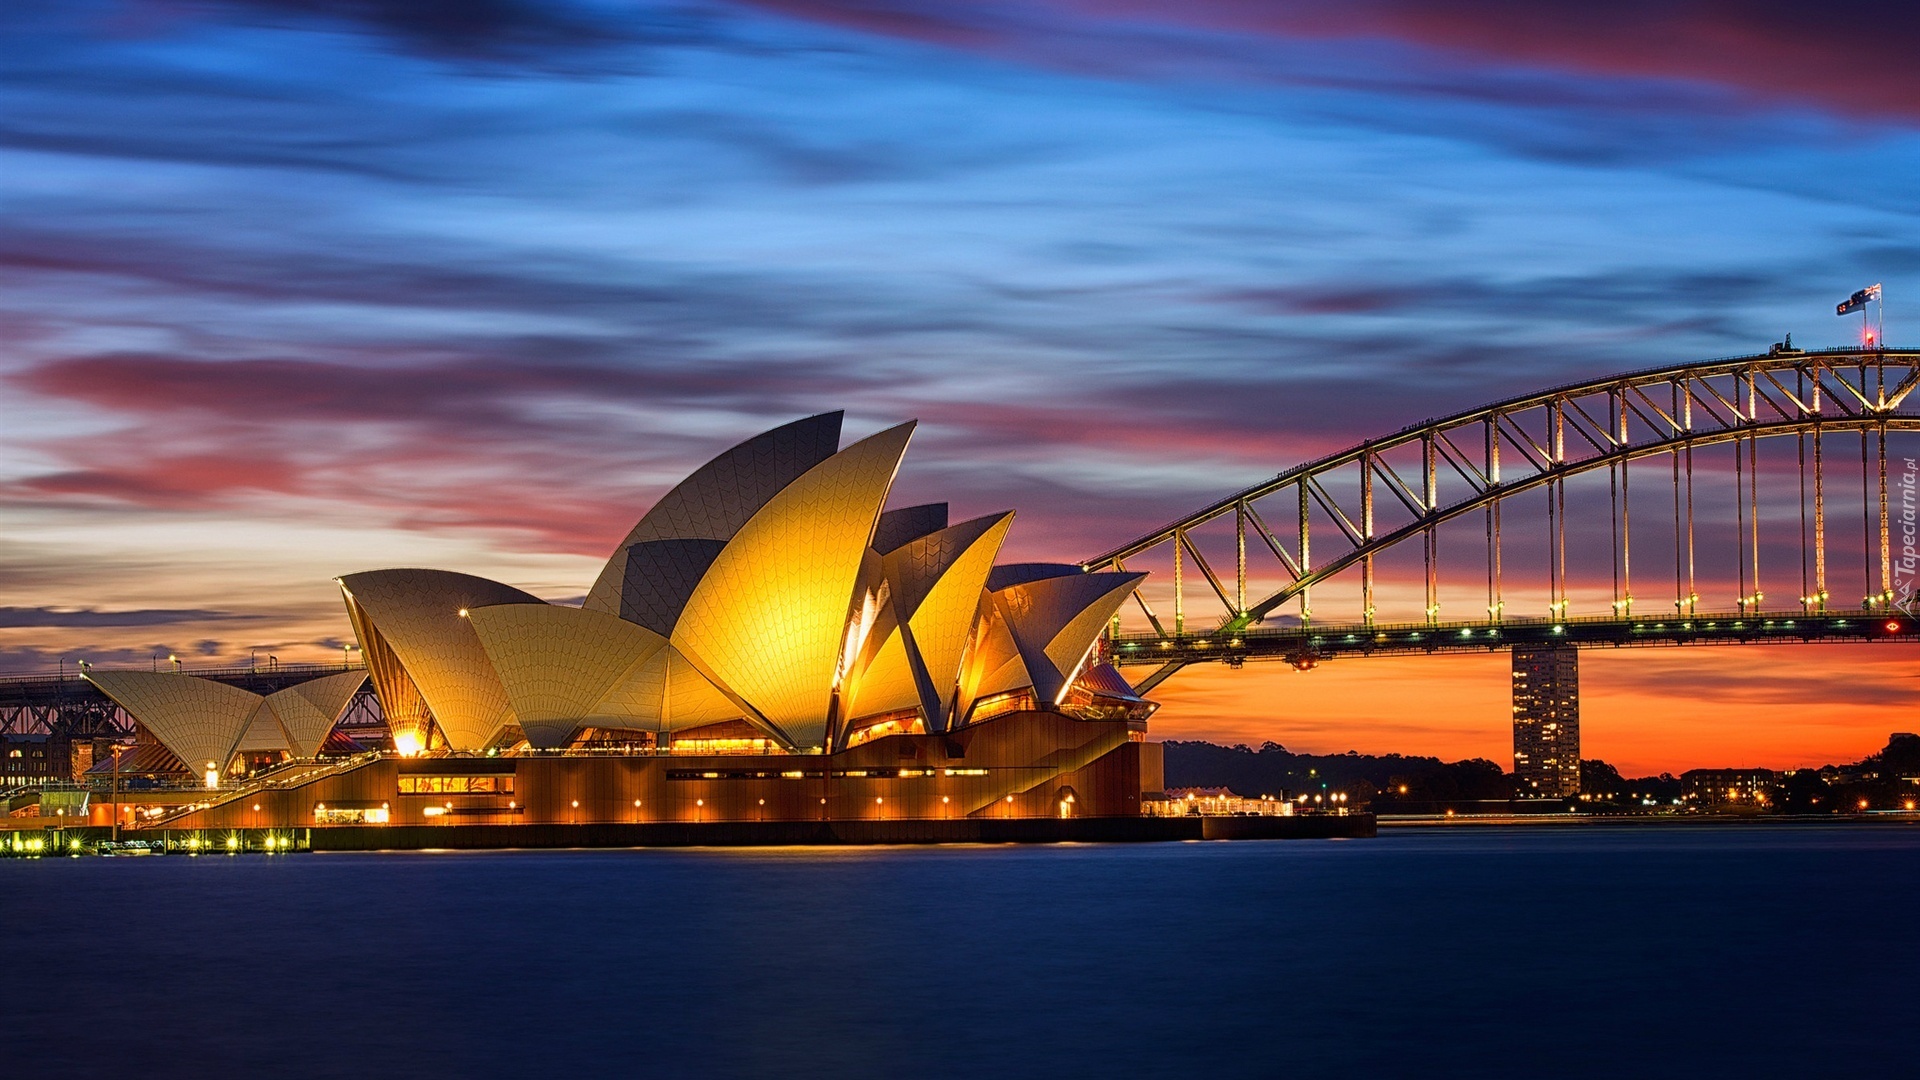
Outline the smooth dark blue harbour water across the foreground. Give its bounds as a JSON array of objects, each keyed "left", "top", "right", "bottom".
[{"left": 0, "top": 826, "right": 1920, "bottom": 1078}]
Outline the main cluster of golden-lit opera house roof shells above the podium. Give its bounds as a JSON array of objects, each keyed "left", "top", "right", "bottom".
[{"left": 340, "top": 413, "right": 1150, "bottom": 753}]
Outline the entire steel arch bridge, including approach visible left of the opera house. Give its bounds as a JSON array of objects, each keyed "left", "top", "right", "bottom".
[{"left": 0, "top": 344, "right": 1920, "bottom": 787}]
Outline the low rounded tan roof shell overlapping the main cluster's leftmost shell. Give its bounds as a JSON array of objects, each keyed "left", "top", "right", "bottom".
[{"left": 467, "top": 603, "right": 666, "bottom": 749}]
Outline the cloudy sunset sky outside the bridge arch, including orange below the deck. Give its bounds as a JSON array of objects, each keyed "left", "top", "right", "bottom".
[{"left": 0, "top": 0, "right": 1920, "bottom": 773}]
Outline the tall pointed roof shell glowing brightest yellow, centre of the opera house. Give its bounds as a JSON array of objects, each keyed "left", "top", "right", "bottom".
[{"left": 672, "top": 423, "right": 914, "bottom": 748}]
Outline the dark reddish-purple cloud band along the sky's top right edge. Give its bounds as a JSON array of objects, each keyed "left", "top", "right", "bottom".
[{"left": 729, "top": 0, "right": 1920, "bottom": 119}]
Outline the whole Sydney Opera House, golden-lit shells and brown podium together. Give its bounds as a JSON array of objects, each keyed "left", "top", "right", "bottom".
[{"left": 90, "top": 413, "right": 1160, "bottom": 828}]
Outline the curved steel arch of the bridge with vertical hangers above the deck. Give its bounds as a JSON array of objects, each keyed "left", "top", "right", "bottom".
[{"left": 1083, "top": 346, "right": 1920, "bottom": 638}]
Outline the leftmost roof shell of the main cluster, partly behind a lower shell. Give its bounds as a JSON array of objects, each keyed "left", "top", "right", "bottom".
[{"left": 340, "top": 569, "right": 541, "bottom": 749}]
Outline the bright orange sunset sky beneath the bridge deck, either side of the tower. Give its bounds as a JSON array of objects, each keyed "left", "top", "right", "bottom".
[{"left": 1154, "top": 644, "right": 1920, "bottom": 776}]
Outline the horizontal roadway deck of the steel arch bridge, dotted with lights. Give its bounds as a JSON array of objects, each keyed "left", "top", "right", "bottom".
[{"left": 1108, "top": 611, "right": 1920, "bottom": 667}]
